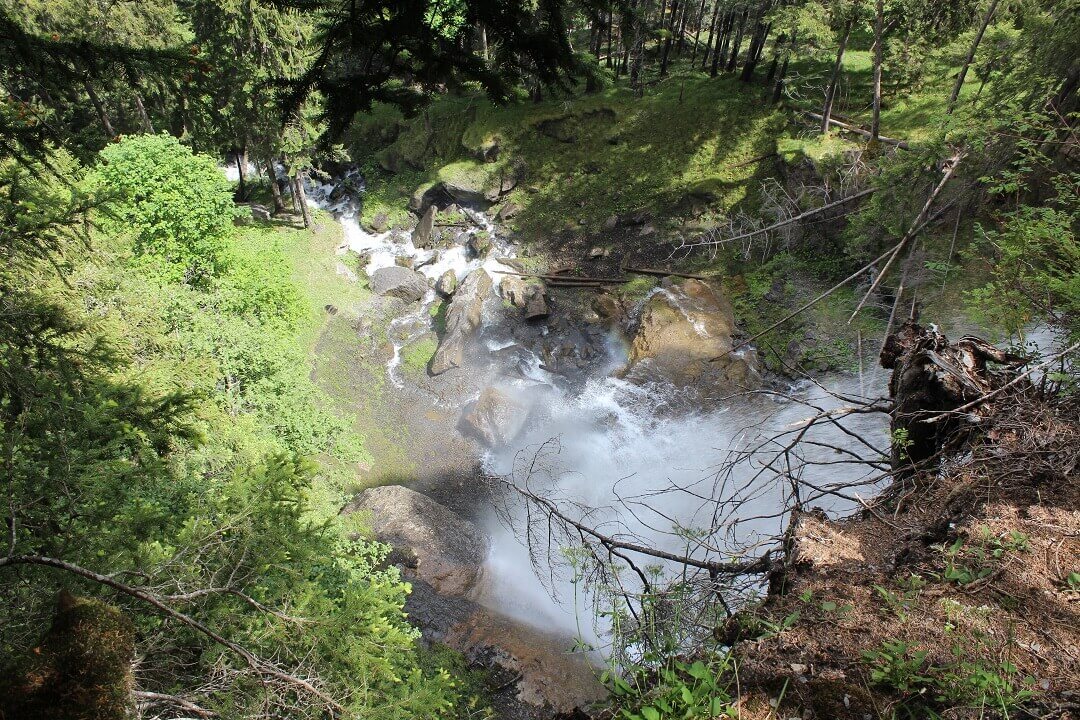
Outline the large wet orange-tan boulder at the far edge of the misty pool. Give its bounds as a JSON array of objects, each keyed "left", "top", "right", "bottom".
[{"left": 627, "top": 280, "right": 761, "bottom": 396}]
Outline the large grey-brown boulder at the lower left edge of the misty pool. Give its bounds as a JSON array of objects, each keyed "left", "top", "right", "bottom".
[{"left": 342, "top": 485, "right": 488, "bottom": 596}]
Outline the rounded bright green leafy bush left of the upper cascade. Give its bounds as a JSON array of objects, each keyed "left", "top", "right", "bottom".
[{"left": 89, "top": 135, "right": 237, "bottom": 285}]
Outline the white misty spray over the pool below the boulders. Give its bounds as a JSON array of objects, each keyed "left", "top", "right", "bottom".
[{"left": 485, "top": 370, "right": 888, "bottom": 642}]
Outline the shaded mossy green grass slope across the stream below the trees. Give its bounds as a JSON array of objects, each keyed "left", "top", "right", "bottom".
[{"left": 354, "top": 76, "right": 784, "bottom": 241}]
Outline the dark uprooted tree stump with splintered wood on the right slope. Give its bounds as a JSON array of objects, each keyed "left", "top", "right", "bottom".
[{"left": 880, "top": 321, "right": 1024, "bottom": 477}]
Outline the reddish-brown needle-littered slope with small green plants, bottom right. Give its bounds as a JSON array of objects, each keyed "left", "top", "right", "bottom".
[{"left": 724, "top": 403, "right": 1080, "bottom": 720}]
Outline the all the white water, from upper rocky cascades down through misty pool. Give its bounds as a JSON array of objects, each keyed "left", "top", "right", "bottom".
[{"left": 293, "top": 175, "right": 902, "bottom": 646}]
